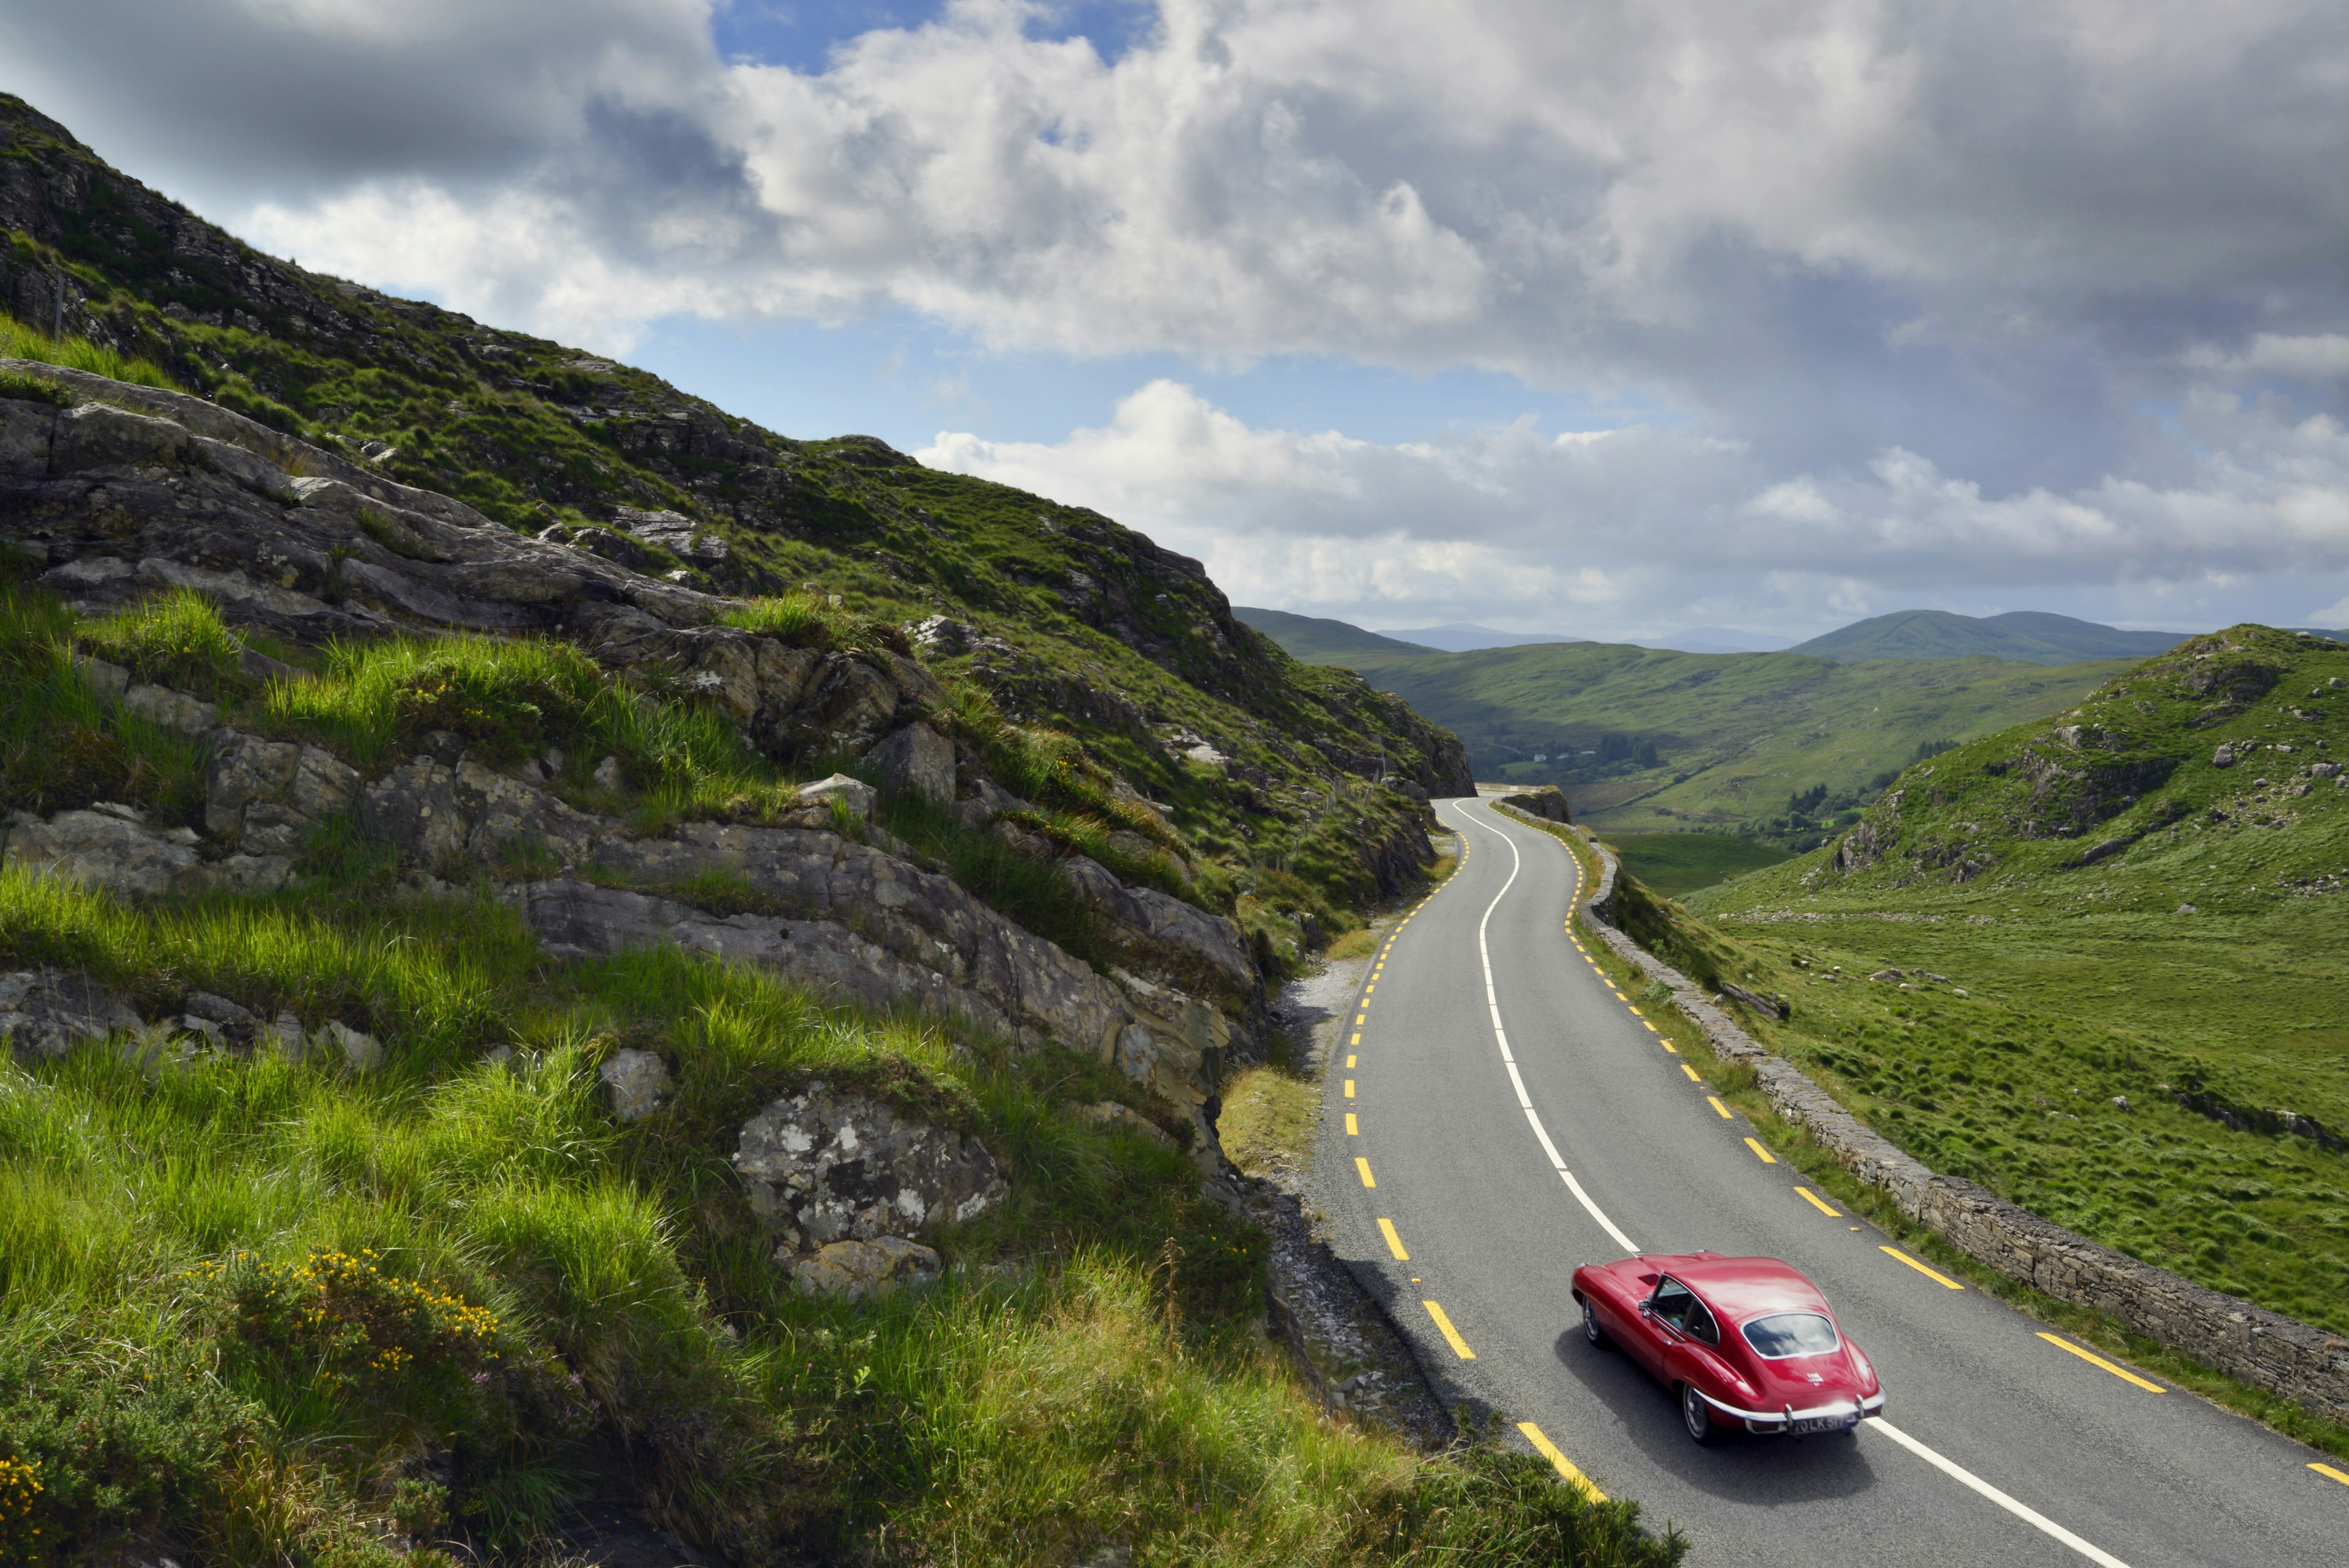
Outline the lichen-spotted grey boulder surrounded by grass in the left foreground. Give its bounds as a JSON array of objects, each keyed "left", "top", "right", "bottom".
[{"left": 733, "top": 1083, "right": 1010, "bottom": 1250}]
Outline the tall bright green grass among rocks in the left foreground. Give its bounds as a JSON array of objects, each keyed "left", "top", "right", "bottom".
[{"left": 0, "top": 595, "right": 1677, "bottom": 1568}]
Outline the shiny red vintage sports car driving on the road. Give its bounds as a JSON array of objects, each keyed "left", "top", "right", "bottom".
[{"left": 1574, "top": 1253, "right": 1884, "bottom": 1443}]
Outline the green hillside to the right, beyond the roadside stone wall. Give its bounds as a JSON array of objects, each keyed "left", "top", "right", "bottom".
[{"left": 1652, "top": 628, "right": 2349, "bottom": 1333}]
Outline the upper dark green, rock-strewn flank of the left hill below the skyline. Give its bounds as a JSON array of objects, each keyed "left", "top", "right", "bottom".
[{"left": 0, "top": 98, "right": 1468, "bottom": 924}]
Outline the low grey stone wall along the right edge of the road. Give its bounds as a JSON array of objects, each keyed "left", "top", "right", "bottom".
[{"left": 1513, "top": 814, "right": 2349, "bottom": 1422}]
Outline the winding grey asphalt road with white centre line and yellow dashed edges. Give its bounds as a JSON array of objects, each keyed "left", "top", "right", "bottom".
[{"left": 1315, "top": 799, "right": 2349, "bottom": 1568}]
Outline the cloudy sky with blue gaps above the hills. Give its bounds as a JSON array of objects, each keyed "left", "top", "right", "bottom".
[{"left": 0, "top": 0, "right": 2349, "bottom": 639}]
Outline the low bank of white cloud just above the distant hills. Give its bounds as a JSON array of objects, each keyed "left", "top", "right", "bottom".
[{"left": 916, "top": 381, "right": 2349, "bottom": 628}]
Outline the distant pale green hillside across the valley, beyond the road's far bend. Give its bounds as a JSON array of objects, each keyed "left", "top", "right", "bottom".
[{"left": 1296, "top": 642, "right": 2126, "bottom": 832}]
